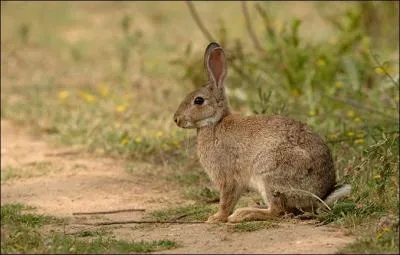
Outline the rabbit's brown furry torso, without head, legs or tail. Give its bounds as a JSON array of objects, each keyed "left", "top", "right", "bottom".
[{"left": 197, "top": 115, "right": 335, "bottom": 201}]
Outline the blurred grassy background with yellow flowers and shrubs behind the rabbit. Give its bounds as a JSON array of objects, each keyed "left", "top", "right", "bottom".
[{"left": 1, "top": 1, "right": 399, "bottom": 251}]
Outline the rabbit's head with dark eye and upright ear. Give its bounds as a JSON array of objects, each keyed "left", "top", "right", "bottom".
[{"left": 174, "top": 42, "right": 229, "bottom": 128}]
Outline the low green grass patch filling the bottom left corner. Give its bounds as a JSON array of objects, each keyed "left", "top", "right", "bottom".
[{"left": 1, "top": 204, "right": 178, "bottom": 254}]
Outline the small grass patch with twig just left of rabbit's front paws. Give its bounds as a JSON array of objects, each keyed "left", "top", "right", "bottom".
[{"left": 147, "top": 204, "right": 217, "bottom": 221}]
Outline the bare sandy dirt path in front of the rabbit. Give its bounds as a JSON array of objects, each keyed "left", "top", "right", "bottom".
[{"left": 1, "top": 120, "right": 355, "bottom": 253}]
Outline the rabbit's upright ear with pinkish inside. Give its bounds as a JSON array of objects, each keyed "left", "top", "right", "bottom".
[{"left": 204, "top": 42, "right": 227, "bottom": 87}]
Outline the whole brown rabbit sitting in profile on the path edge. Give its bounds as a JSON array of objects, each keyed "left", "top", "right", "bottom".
[{"left": 174, "top": 42, "right": 351, "bottom": 223}]
